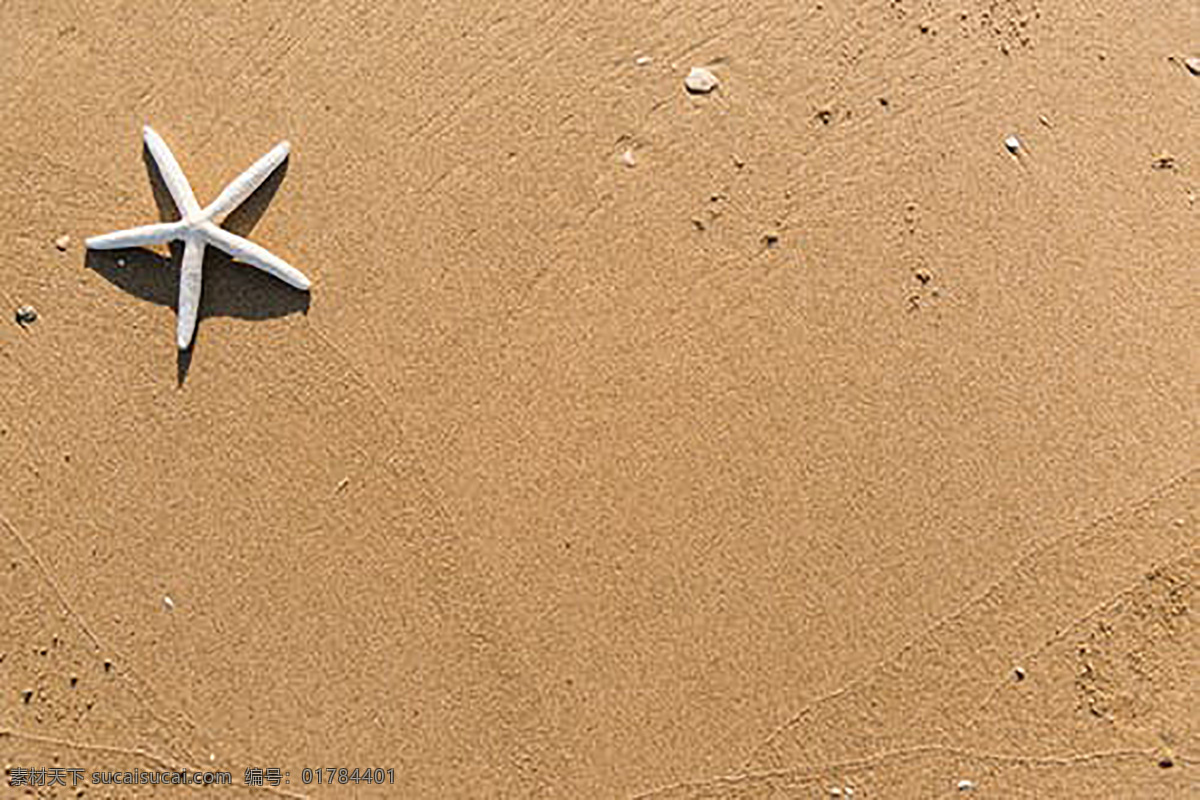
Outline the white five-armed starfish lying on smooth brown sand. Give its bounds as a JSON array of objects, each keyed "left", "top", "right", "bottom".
[{"left": 85, "top": 125, "right": 312, "bottom": 350}]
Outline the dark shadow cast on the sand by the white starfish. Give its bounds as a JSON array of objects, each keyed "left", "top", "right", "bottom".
[{"left": 85, "top": 141, "right": 310, "bottom": 385}]
